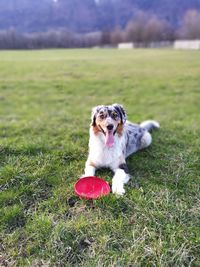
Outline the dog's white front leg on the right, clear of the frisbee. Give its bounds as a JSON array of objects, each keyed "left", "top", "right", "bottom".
[{"left": 112, "top": 163, "right": 130, "bottom": 195}]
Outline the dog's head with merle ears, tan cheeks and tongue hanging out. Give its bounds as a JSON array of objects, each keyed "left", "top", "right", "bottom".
[{"left": 91, "top": 104, "right": 126, "bottom": 147}]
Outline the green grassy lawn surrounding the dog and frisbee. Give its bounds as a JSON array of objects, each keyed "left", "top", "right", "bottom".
[{"left": 0, "top": 50, "right": 200, "bottom": 267}]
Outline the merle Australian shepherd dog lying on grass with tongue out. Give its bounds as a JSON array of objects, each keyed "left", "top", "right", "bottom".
[{"left": 83, "top": 104, "right": 160, "bottom": 195}]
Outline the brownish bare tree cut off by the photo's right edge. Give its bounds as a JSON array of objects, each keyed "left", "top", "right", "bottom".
[{"left": 179, "top": 10, "right": 200, "bottom": 39}]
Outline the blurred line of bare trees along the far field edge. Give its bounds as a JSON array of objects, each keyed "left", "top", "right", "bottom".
[{"left": 0, "top": 10, "right": 200, "bottom": 49}]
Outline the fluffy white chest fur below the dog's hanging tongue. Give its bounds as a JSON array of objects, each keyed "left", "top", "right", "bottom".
[{"left": 89, "top": 130, "right": 125, "bottom": 171}]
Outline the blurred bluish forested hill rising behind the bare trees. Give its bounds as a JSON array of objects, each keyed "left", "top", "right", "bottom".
[{"left": 0, "top": 0, "right": 200, "bottom": 33}]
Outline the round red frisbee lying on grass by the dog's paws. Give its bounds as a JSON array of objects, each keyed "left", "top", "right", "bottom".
[{"left": 74, "top": 176, "right": 110, "bottom": 199}]
